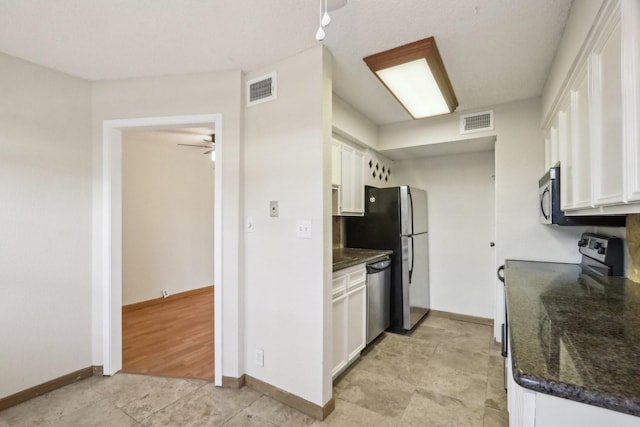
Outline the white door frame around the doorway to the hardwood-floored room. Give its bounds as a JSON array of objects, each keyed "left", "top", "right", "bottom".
[{"left": 100, "top": 113, "right": 224, "bottom": 386}]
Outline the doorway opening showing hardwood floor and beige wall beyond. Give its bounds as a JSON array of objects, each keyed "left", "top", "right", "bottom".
[{"left": 122, "top": 127, "right": 215, "bottom": 381}]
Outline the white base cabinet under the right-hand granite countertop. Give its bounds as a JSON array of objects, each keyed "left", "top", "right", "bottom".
[{"left": 506, "top": 349, "right": 640, "bottom": 427}]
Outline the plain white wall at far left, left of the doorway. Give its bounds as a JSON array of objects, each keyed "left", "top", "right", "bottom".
[{"left": 0, "top": 53, "right": 92, "bottom": 398}]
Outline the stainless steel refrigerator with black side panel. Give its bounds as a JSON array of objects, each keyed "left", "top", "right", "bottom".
[{"left": 345, "top": 185, "right": 429, "bottom": 332}]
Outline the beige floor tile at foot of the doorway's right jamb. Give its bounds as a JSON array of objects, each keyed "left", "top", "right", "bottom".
[{"left": 142, "top": 384, "right": 261, "bottom": 427}]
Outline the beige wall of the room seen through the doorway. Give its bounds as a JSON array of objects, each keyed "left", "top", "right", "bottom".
[{"left": 122, "top": 131, "right": 214, "bottom": 305}]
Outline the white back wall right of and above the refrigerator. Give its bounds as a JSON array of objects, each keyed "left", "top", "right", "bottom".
[{"left": 395, "top": 151, "right": 495, "bottom": 318}]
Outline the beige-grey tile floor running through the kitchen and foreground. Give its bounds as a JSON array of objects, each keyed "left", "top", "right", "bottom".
[{"left": 0, "top": 316, "right": 508, "bottom": 427}]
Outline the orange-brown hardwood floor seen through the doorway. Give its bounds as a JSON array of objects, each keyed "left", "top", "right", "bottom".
[{"left": 122, "top": 286, "right": 214, "bottom": 381}]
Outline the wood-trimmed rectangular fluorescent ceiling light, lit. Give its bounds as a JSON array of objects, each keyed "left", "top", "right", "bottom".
[{"left": 364, "top": 37, "right": 458, "bottom": 119}]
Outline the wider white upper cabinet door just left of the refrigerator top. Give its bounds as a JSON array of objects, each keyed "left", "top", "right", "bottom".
[{"left": 340, "top": 143, "right": 364, "bottom": 215}]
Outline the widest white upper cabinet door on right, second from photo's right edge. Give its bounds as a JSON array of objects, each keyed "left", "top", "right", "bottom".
[{"left": 589, "top": 9, "right": 624, "bottom": 206}]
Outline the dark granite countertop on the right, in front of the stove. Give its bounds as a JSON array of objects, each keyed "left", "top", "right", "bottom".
[{"left": 505, "top": 260, "right": 640, "bottom": 416}]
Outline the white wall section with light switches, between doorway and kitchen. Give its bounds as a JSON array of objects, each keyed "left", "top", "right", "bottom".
[{"left": 244, "top": 46, "right": 331, "bottom": 405}]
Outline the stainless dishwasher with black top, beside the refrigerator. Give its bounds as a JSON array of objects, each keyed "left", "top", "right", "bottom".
[{"left": 367, "top": 257, "right": 391, "bottom": 345}]
